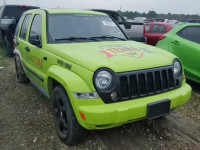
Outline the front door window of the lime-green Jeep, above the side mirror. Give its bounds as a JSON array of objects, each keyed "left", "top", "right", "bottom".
[{"left": 29, "top": 15, "right": 42, "bottom": 39}]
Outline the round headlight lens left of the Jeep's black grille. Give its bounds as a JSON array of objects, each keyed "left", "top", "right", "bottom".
[{"left": 95, "top": 71, "right": 113, "bottom": 90}]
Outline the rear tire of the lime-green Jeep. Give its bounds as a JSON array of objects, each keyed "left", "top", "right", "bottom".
[{"left": 15, "top": 55, "right": 30, "bottom": 83}]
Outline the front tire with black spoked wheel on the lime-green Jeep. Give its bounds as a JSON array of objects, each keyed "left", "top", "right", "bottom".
[{"left": 51, "top": 85, "right": 86, "bottom": 145}]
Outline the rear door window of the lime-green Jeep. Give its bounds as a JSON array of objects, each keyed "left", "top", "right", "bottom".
[{"left": 19, "top": 14, "right": 32, "bottom": 39}]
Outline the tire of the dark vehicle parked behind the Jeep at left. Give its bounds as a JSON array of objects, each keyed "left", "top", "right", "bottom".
[{"left": 3, "top": 36, "right": 14, "bottom": 57}]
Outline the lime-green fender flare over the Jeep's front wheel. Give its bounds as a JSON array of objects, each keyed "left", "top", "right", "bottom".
[{"left": 47, "top": 65, "right": 95, "bottom": 126}]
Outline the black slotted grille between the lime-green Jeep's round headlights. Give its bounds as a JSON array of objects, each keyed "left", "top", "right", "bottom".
[{"left": 119, "top": 67, "right": 176, "bottom": 100}]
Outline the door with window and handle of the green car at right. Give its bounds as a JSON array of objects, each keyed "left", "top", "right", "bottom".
[{"left": 170, "top": 26, "right": 200, "bottom": 80}]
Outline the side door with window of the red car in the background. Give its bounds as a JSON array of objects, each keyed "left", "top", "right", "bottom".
[{"left": 145, "top": 25, "right": 167, "bottom": 46}]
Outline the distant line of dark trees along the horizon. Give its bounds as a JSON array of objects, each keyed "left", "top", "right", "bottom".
[{"left": 118, "top": 10, "right": 200, "bottom": 21}]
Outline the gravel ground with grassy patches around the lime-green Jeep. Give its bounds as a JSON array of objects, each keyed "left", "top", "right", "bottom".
[{"left": 0, "top": 48, "right": 200, "bottom": 150}]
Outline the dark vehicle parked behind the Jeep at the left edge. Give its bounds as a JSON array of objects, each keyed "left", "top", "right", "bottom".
[{"left": 0, "top": 5, "right": 38, "bottom": 56}]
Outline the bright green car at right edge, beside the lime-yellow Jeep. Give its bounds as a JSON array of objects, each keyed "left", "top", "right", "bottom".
[{"left": 156, "top": 23, "right": 200, "bottom": 83}]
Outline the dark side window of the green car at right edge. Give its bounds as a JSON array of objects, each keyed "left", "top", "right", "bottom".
[{"left": 178, "top": 26, "right": 200, "bottom": 44}]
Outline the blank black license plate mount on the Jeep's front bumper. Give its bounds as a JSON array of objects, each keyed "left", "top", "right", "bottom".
[{"left": 147, "top": 99, "right": 171, "bottom": 120}]
